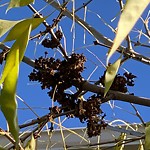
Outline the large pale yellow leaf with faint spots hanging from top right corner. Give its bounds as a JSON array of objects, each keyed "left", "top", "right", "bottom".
[{"left": 107, "top": 0, "right": 150, "bottom": 64}]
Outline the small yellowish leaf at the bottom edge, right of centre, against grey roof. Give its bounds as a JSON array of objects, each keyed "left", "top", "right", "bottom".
[{"left": 114, "top": 133, "right": 126, "bottom": 150}]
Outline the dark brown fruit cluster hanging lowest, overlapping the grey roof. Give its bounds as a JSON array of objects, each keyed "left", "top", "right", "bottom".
[{"left": 77, "top": 95, "right": 107, "bottom": 137}]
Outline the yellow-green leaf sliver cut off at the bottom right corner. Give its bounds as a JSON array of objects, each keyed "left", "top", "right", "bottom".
[{"left": 144, "top": 122, "right": 150, "bottom": 150}]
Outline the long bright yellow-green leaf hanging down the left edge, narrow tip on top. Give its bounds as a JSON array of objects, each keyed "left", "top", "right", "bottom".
[{"left": 0, "top": 49, "right": 19, "bottom": 143}]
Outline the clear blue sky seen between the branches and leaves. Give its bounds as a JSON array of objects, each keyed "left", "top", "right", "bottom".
[{"left": 0, "top": 0, "right": 150, "bottom": 128}]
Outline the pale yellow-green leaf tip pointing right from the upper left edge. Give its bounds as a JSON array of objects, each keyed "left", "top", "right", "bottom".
[{"left": 0, "top": 19, "right": 20, "bottom": 37}]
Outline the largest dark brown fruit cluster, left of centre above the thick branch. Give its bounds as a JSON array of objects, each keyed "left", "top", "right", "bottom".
[{"left": 29, "top": 54, "right": 86, "bottom": 106}]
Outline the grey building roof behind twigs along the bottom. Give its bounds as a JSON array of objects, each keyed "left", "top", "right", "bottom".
[{"left": 0, "top": 124, "right": 144, "bottom": 150}]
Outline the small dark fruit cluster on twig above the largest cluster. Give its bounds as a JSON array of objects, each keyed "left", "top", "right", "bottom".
[{"left": 42, "top": 30, "right": 63, "bottom": 49}]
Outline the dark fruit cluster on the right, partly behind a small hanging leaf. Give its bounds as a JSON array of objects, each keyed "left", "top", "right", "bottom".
[{"left": 99, "top": 72, "right": 136, "bottom": 93}]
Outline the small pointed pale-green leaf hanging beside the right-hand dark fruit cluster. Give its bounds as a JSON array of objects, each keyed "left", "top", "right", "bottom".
[{"left": 104, "top": 57, "right": 121, "bottom": 96}]
